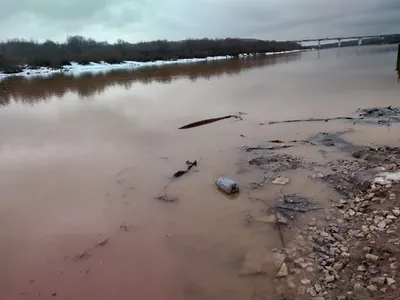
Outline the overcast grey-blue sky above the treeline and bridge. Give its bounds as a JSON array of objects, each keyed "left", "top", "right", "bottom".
[{"left": 0, "top": 0, "right": 400, "bottom": 42}]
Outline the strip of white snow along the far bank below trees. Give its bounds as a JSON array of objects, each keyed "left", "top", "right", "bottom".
[{"left": 0, "top": 50, "right": 302, "bottom": 80}]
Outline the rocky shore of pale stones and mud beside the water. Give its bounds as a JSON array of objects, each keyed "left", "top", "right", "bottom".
[{"left": 241, "top": 108, "right": 400, "bottom": 300}]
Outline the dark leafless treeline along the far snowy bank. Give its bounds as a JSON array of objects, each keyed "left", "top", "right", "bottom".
[{"left": 0, "top": 36, "right": 301, "bottom": 72}]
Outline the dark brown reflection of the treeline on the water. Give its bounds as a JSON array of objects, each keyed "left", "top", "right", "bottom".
[{"left": 0, "top": 53, "right": 300, "bottom": 105}]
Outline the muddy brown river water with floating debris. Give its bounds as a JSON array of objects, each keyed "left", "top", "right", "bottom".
[{"left": 0, "top": 46, "right": 400, "bottom": 300}]
